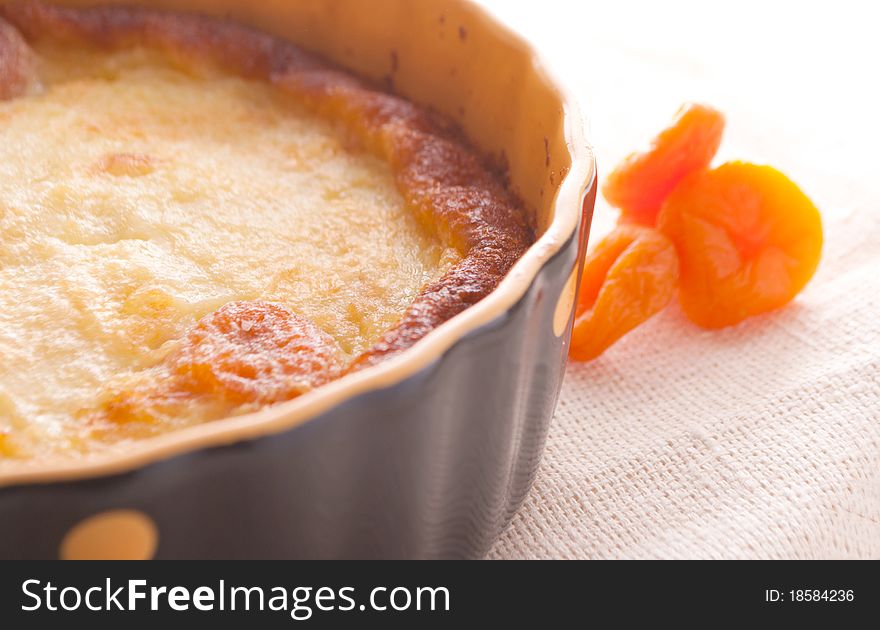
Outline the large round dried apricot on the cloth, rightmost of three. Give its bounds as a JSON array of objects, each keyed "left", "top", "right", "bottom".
[{"left": 658, "top": 162, "right": 822, "bottom": 328}]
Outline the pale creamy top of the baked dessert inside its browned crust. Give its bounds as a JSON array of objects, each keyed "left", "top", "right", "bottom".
[{"left": 0, "top": 43, "right": 461, "bottom": 459}]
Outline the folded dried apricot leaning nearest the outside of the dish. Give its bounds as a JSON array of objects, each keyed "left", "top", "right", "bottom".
[{"left": 569, "top": 225, "right": 678, "bottom": 361}]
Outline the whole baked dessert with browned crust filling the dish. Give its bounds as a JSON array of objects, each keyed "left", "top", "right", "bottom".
[{"left": 0, "top": 2, "right": 534, "bottom": 466}]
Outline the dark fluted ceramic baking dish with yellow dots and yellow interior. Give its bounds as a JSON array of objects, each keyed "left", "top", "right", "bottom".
[{"left": 0, "top": 0, "right": 595, "bottom": 558}]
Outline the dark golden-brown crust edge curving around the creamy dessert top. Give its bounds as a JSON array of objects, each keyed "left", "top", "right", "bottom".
[{"left": 0, "top": 2, "right": 534, "bottom": 371}]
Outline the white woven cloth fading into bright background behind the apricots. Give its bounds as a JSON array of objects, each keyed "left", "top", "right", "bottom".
[{"left": 485, "top": 0, "right": 880, "bottom": 558}]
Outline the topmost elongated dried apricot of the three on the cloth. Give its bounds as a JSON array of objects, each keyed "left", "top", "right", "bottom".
[{"left": 602, "top": 104, "right": 724, "bottom": 225}]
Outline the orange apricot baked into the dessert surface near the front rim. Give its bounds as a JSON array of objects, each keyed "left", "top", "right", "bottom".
[{"left": 170, "top": 301, "right": 343, "bottom": 404}]
